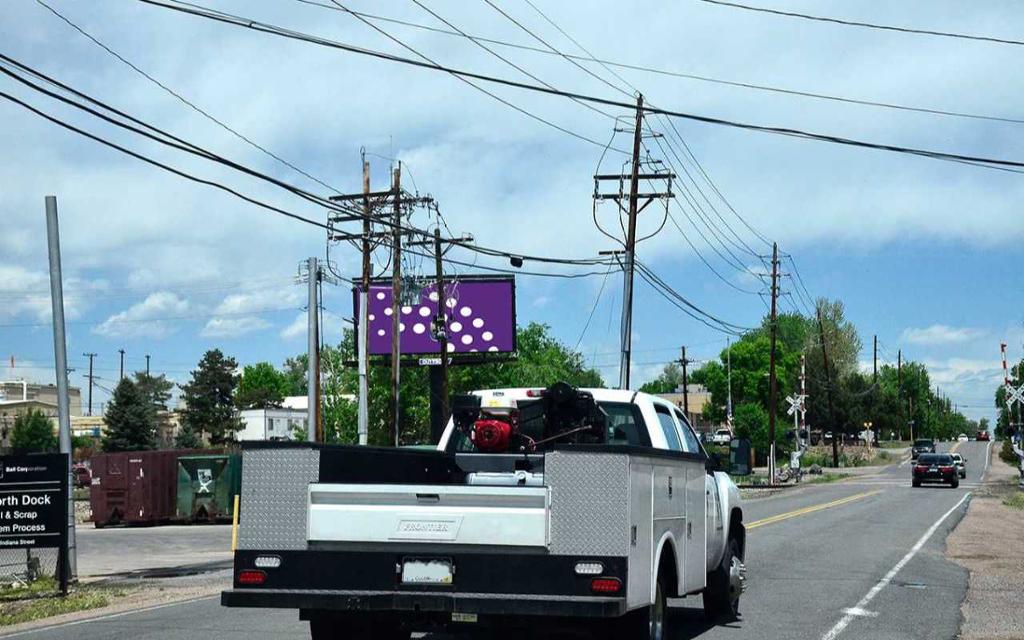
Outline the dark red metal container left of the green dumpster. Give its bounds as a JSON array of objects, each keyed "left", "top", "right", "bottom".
[{"left": 89, "top": 450, "right": 209, "bottom": 528}]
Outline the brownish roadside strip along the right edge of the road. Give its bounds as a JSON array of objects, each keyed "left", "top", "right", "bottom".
[{"left": 946, "top": 442, "right": 1024, "bottom": 640}]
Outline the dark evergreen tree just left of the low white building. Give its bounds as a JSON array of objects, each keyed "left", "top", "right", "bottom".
[{"left": 181, "top": 349, "right": 242, "bottom": 444}]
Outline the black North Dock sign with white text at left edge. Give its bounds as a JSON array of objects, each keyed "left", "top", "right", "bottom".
[{"left": 0, "top": 454, "right": 68, "bottom": 549}]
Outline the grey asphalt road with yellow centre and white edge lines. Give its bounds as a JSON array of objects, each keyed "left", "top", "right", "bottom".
[{"left": 6, "top": 442, "right": 986, "bottom": 640}]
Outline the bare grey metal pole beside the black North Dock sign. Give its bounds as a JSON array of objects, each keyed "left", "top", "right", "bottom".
[{"left": 46, "top": 196, "right": 78, "bottom": 595}]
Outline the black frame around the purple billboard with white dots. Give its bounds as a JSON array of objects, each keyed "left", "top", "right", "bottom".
[{"left": 345, "top": 273, "right": 519, "bottom": 367}]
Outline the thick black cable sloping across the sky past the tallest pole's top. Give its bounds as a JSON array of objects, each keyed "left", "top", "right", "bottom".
[{"left": 136, "top": 0, "right": 1024, "bottom": 173}]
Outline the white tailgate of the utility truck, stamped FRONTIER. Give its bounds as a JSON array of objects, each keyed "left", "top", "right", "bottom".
[{"left": 307, "top": 483, "right": 550, "bottom": 548}]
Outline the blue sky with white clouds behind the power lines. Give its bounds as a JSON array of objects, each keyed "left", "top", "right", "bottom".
[{"left": 0, "top": 0, "right": 1024, "bottom": 417}]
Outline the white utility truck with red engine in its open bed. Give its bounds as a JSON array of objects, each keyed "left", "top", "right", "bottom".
[{"left": 221, "top": 383, "right": 745, "bottom": 640}]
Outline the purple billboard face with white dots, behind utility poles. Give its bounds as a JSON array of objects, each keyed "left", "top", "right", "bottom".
[{"left": 354, "top": 276, "right": 516, "bottom": 355}]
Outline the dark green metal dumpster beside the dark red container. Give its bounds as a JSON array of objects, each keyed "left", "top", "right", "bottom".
[{"left": 177, "top": 454, "right": 242, "bottom": 522}]
